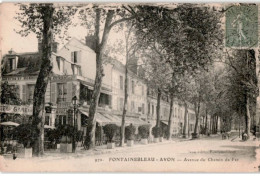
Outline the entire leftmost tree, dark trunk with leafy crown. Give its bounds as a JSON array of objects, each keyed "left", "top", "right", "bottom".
[{"left": 16, "top": 3, "right": 75, "bottom": 156}]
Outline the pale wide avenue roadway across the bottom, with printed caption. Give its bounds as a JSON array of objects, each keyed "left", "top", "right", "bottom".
[{"left": 1, "top": 134, "right": 260, "bottom": 172}]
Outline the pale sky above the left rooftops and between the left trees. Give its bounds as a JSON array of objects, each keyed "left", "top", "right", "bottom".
[{"left": 0, "top": 3, "right": 126, "bottom": 58}]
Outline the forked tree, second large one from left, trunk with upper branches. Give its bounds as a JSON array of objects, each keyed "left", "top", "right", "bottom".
[{"left": 79, "top": 5, "right": 133, "bottom": 149}]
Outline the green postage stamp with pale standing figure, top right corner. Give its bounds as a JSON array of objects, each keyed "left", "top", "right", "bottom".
[{"left": 225, "top": 5, "right": 258, "bottom": 48}]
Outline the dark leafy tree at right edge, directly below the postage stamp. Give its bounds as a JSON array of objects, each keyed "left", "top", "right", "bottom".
[{"left": 218, "top": 50, "right": 259, "bottom": 137}]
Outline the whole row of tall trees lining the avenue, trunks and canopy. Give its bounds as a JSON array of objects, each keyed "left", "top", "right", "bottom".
[{"left": 17, "top": 4, "right": 258, "bottom": 155}]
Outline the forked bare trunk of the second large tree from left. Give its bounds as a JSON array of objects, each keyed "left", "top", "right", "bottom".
[{"left": 85, "top": 7, "right": 114, "bottom": 149}]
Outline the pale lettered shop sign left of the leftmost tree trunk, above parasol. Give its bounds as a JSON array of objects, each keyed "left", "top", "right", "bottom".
[{"left": 0, "top": 105, "right": 33, "bottom": 115}]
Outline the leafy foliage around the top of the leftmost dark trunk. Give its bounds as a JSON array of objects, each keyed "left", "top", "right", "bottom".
[{"left": 15, "top": 3, "right": 77, "bottom": 39}]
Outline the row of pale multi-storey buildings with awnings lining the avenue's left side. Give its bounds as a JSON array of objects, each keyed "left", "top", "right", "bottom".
[{"left": 0, "top": 37, "right": 213, "bottom": 140}]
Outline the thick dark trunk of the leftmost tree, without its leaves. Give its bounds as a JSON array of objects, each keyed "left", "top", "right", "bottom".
[{"left": 32, "top": 4, "right": 54, "bottom": 156}]
